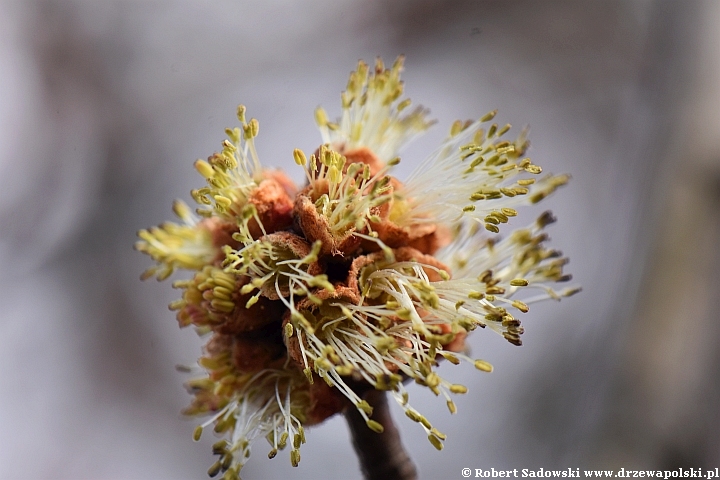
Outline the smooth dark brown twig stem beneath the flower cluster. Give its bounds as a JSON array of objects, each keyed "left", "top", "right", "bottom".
[{"left": 345, "top": 390, "right": 417, "bottom": 480}]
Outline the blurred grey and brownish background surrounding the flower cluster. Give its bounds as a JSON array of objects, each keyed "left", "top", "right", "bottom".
[{"left": 0, "top": 0, "right": 720, "bottom": 479}]
